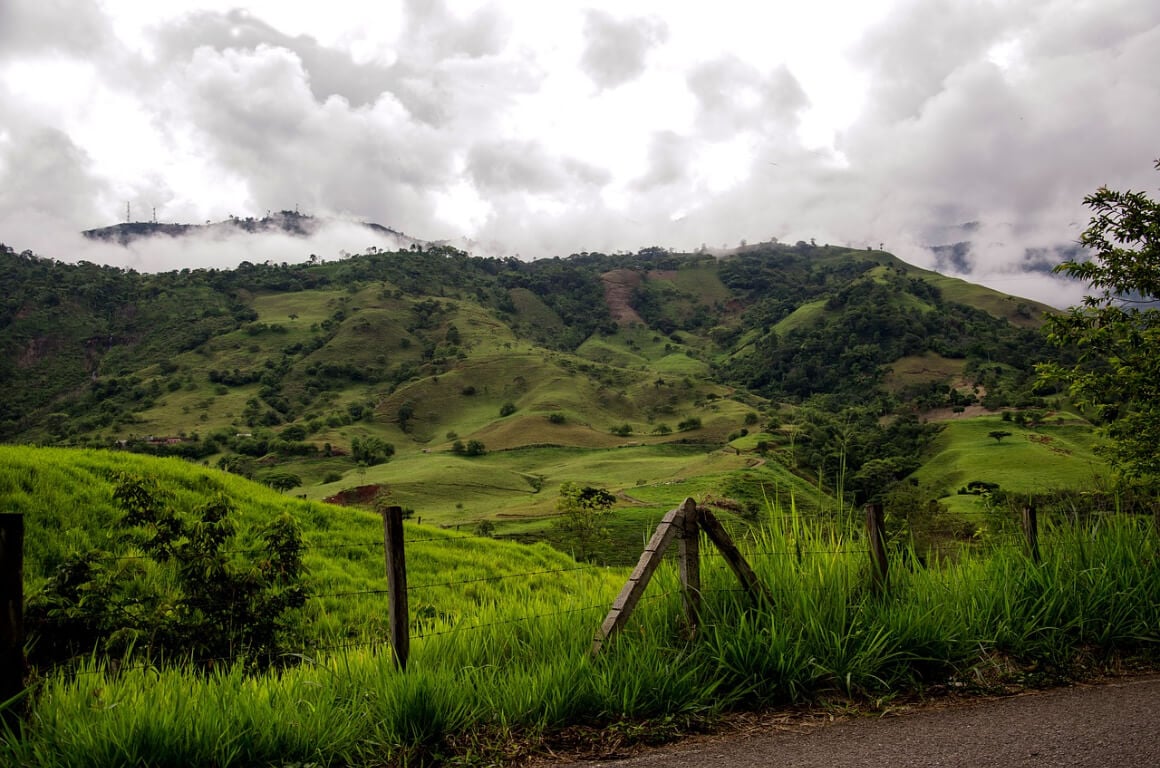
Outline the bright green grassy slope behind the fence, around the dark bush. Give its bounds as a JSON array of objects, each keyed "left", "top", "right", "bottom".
[{"left": 0, "top": 445, "right": 619, "bottom": 640}]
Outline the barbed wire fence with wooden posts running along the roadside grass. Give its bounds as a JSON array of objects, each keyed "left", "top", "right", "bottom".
[{"left": 0, "top": 499, "right": 1062, "bottom": 702}]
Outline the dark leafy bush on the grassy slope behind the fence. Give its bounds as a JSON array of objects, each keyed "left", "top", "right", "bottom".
[{"left": 26, "top": 474, "right": 306, "bottom": 667}]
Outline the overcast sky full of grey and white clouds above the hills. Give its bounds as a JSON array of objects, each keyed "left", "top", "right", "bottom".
[{"left": 0, "top": 0, "right": 1160, "bottom": 305}]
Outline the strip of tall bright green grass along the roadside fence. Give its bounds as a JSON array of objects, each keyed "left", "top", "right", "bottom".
[{"left": 0, "top": 498, "right": 1160, "bottom": 768}]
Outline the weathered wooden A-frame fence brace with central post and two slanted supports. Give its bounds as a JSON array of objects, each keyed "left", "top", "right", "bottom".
[{"left": 592, "top": 499, "right": 773, "bottom": 653}]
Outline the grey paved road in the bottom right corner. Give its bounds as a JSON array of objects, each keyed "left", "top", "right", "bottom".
[{"left": 553, "top": 676, "right": 1160, "bottom": 768}]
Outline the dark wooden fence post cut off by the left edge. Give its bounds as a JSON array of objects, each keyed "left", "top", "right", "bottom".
[{"left": 0, "top": 514, "right": 24, "bottom": 731}]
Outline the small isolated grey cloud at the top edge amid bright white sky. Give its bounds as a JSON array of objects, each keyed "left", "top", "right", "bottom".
[{"left": 580, "top": 10, "right": 668, "bottom": 88}]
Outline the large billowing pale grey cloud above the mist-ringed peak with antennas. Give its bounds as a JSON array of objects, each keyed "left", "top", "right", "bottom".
[{"left": 176, "top": 48, "right": 451, "bottom": 228}]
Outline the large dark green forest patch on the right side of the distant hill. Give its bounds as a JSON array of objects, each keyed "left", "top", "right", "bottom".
[{"left": 722, "top": 251, "right": 1043, "bottom": 407}]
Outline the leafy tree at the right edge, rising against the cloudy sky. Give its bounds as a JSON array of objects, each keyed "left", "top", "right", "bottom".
[{"left": 1039, "top": 161, "right": 1160, "bottom": 481}]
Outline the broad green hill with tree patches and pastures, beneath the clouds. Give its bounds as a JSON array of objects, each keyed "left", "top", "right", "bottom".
[{"left": 0, "top": 237, "right": 1086, "bottom": 560}]
